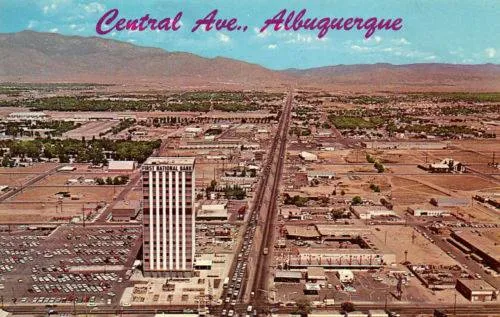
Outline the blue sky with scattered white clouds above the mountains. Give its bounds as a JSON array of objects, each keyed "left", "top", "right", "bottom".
[{"left": 0, "top": 0, "right": 500, "bottom": 69}]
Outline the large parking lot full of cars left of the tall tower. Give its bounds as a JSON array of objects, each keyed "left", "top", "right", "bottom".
[{"left": 0, "top": 226, "right": 141, "bottom": 306}]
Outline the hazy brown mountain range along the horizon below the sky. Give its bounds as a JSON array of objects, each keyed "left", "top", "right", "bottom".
[{"left": 0, "top": 31, "right": 500, "bottom": 91}]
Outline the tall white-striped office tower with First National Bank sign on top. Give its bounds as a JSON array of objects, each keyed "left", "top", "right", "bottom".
[{"left": 142, "top": 157, "right": 195, "bottom": 277}]
